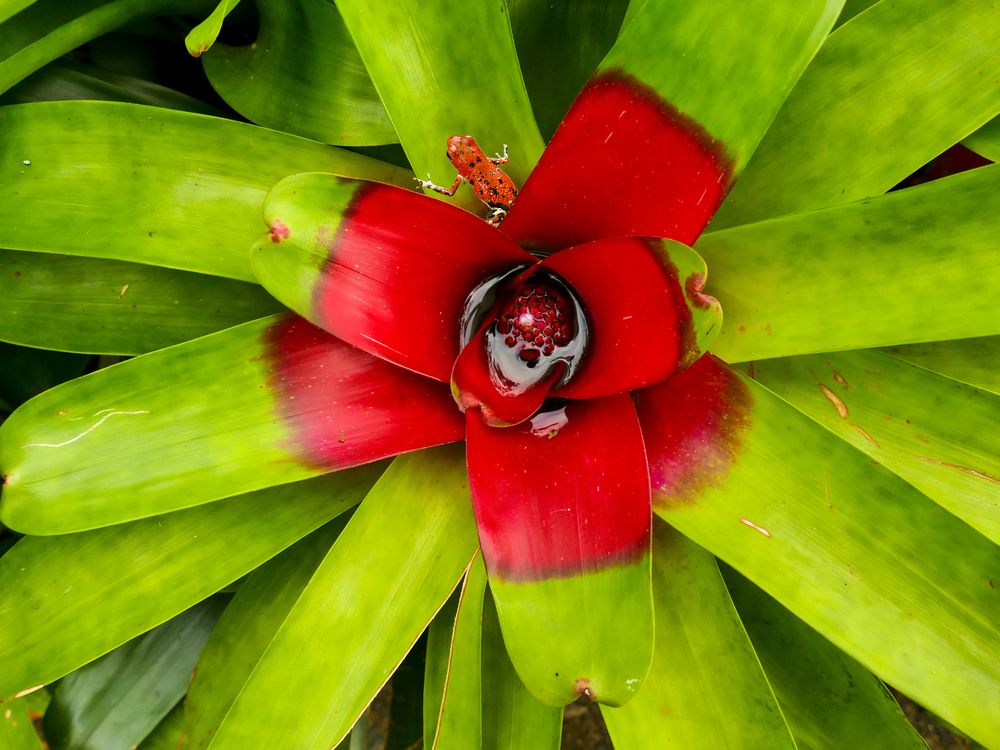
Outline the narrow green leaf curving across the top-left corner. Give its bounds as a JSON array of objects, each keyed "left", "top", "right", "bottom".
[{"left": 0, "top": 0, "right": 209, "bottom": 93}]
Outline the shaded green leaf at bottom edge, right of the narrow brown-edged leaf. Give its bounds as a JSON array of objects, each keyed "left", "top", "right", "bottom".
[{"left": 482, "top": 596, "right": 563, "bottom": 750}]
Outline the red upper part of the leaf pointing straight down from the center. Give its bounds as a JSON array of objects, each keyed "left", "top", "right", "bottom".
[{"left": 466, "top": 394, "right": 652, "bottom": 583}]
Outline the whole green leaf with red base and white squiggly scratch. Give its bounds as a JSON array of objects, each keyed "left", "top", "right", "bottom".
[{"left": 0, "top": 315, "right": 463, "bottom": 534}]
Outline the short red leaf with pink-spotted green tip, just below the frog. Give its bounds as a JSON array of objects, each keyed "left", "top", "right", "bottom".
[{"left": 252, "top": 173, "right": 534, "bottom": 382}]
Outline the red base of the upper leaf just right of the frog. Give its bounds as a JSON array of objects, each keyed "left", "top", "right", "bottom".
[{"left": 501, "top": 70, "right": 732, "bottom": 251}]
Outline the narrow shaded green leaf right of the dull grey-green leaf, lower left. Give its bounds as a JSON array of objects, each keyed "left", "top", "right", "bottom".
[{"left": 184, "top": 514, "right": 347, "bottom": 750}]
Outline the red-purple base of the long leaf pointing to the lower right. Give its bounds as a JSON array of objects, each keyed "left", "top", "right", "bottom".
[{"left": 634, "top": 355, "right": 752, "bottom": 507}]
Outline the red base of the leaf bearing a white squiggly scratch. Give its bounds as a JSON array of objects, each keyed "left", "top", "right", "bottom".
[{"left": 264, "top": 315, "right": 465, "bottom": 470}]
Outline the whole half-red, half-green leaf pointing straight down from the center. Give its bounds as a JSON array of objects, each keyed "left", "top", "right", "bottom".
[{"left": 467, "top": 394, "right": 653, "bottom": 705}]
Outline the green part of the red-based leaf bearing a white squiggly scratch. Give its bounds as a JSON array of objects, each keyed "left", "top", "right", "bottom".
[{"left": 0, "top": 317, "right": 360, "bottom": 534}]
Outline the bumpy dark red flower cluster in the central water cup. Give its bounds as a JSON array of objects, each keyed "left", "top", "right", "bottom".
[{"left": 497, "top": 282, "right": 573, "bottom": 366}]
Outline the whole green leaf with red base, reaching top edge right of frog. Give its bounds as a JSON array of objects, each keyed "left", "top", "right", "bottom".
[{"left": 503, "top": 0, "right": 841, "bottom": 250}]
